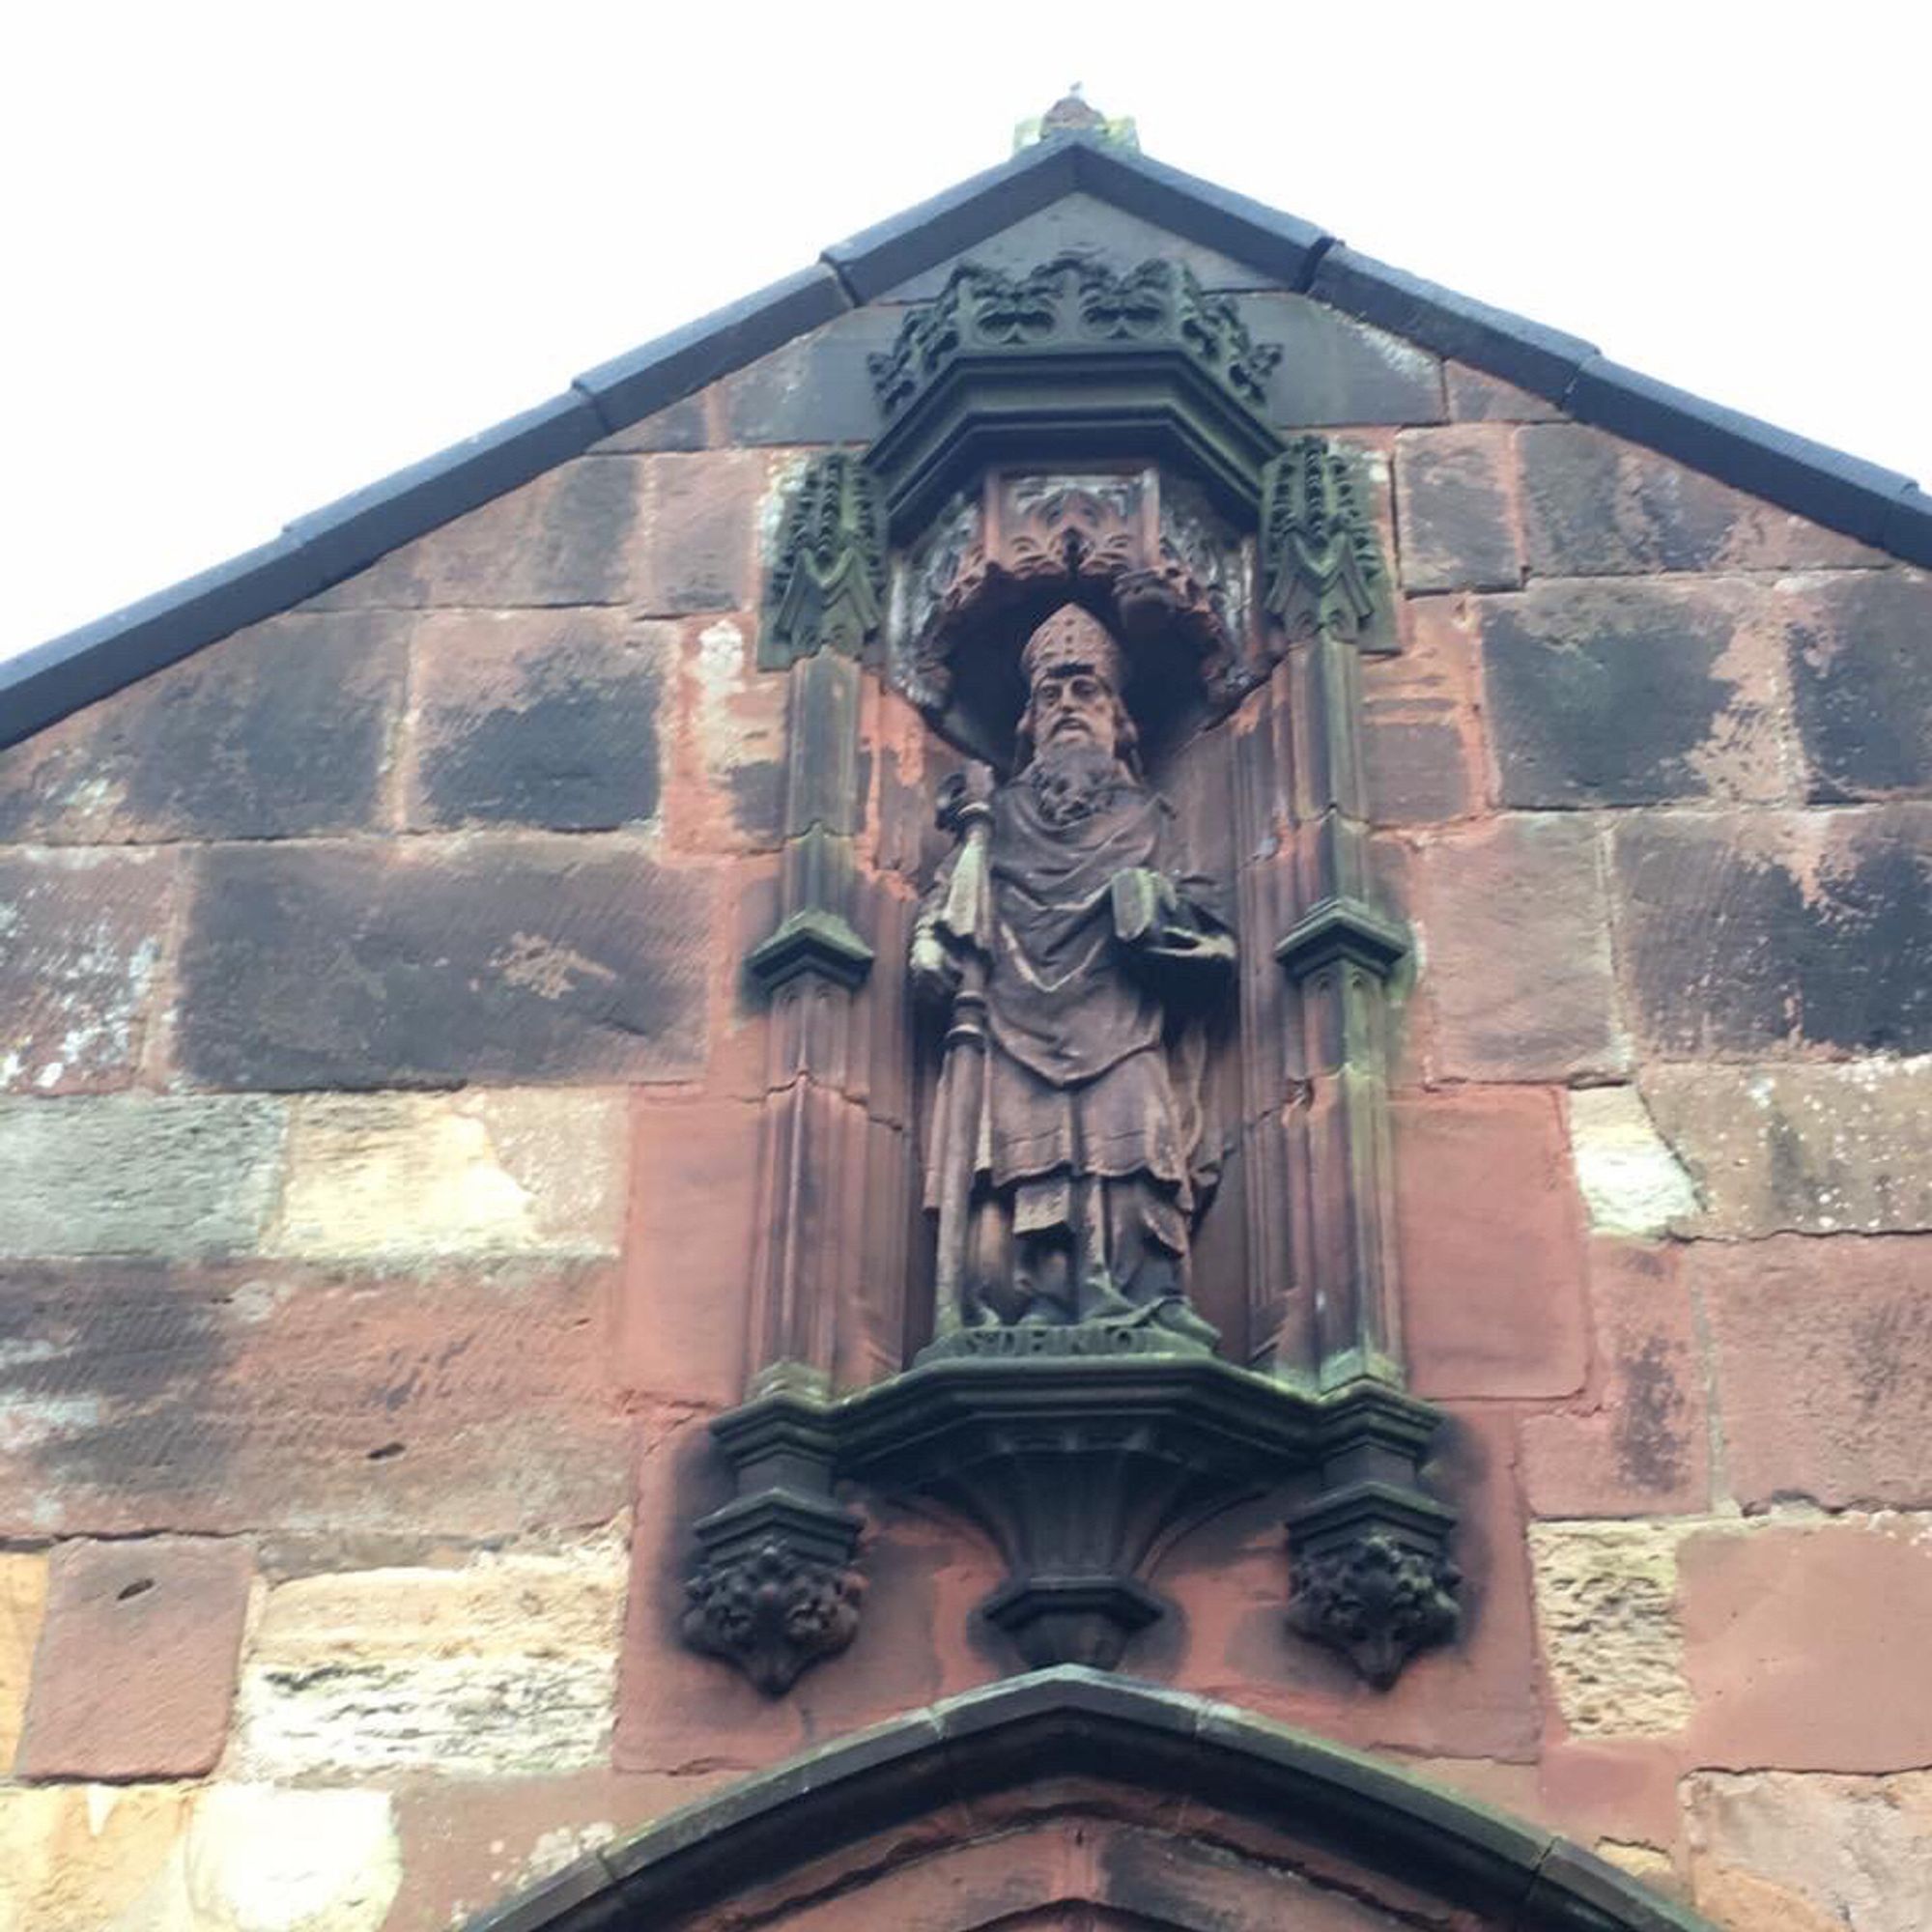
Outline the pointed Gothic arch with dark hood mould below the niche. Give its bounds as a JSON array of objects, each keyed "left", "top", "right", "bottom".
[{"left": 471, "top": 1665, "right": 1708, "bottom": 1932}]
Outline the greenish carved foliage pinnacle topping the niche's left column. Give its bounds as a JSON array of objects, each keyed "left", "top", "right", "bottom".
[{"left": 757, "top": 450, "right": 885, "bottom": 670}]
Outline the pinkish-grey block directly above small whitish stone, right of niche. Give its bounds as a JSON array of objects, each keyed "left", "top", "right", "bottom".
[{"left": 1416, "top": 817, "right": 1627, "bottom": 1080}]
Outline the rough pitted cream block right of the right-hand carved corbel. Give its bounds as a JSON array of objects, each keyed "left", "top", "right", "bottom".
[{"left": 1530, "top": 1522, "right": 1692, "bottom": 1737}]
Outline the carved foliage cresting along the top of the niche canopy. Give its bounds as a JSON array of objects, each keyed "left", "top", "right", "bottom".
[{"left": 869, "top": 253, "right": 1281, "bottom": 417}]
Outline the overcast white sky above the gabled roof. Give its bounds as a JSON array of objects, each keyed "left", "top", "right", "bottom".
[{"left": 0, "top": 0, "right": 1932, "bottom": 655}]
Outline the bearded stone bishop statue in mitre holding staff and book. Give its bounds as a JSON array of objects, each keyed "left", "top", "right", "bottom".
[{"left": 910, "top": 605, "right": 1235, "bottom": 1345}]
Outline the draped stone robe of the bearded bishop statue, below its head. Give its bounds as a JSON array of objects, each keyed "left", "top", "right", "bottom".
[{"left": 922, "top": 773, "right": 1233, "bottom": 1325}]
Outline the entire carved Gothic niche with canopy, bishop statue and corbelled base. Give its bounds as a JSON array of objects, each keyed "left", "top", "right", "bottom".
[{"left": 686, "top": 255, "right": 1459, "bottom": 1692}]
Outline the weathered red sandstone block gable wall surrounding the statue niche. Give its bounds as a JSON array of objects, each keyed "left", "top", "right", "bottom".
[{"left": 0, "top": 208, "right": 1932, "bottom": 1932}]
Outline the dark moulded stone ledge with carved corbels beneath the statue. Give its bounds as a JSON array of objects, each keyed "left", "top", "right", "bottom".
[{"left": 684, "top": 1360, "right": 1457, "bottom": 1694}]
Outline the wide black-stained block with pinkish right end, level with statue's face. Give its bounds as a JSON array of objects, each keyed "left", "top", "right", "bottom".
[{"left": 1480, "top": 582, "right": 1801, "bottom": 808}]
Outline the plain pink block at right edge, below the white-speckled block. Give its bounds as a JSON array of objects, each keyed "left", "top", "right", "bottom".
[{"left": 1685, "top": 1235, "right": 1932, "bottom": 1509}]
